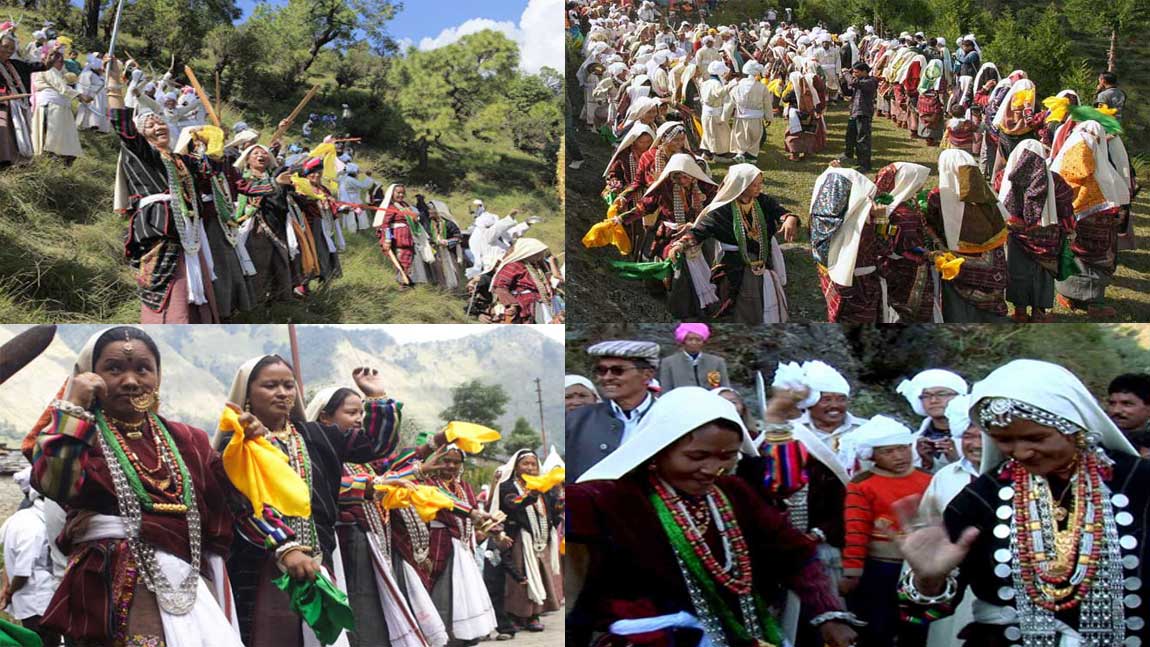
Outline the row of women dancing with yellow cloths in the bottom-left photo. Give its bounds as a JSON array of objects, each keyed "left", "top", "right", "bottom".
[{"left": 0, "top": 326, "right": 564, "bottom": 647}]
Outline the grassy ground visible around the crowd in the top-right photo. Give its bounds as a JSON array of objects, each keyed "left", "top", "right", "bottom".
[{"left": 567, "top": 106, "right": 1150, "bottom": 323}]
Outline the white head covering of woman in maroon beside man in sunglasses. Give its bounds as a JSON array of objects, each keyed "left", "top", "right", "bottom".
[{"left": 576, "top": 386, "right": 756, "bottom": 483}]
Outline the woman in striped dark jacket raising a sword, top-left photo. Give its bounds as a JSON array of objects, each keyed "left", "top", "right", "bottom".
[{"left": 105, "top": 59, "right": 222, "bottom": 323}]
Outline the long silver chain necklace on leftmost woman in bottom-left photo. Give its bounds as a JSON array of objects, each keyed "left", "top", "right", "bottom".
[{"left": 95, "top": 409, "right": 201, "bottom": 616}]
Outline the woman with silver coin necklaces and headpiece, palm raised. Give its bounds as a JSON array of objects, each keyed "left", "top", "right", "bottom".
[{"left": 898, "top": 360, "right": 1150, "bottom": 647}]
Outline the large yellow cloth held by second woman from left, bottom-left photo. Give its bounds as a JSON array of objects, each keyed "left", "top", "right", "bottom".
[{"left": 220, "top": 408, "right": 312, "bottom": 517}]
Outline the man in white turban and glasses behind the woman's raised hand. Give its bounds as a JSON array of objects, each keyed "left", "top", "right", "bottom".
[{"left": 895, "top": 369, "right": 968, "bottom": 473}]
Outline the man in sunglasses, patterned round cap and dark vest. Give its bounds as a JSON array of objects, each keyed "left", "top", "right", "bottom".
[{"left": 566, "top": 340, "right": 659, "bottom": 483}]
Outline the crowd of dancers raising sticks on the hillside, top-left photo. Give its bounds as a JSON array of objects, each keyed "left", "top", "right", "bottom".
[{"left": 0, "top": 22, "right": 564, "bottom": 323}]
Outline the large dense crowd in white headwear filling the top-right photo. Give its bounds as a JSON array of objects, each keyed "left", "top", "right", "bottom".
[{"left": 568, "top": 0, "right": 1139, "bottom": 323}]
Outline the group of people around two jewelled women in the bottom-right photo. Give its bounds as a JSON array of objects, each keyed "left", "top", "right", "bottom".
[{"left": 566, "top": 324, "right": 1150, "bottom": 647}]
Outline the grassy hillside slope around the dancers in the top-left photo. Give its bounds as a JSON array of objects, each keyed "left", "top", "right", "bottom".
[{"left": 0, "top": 103, "right": 564, "bottom": 323}]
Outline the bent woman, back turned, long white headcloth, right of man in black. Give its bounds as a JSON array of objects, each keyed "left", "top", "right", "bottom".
[{"left": 811, "top": 162, "right": 886, "bottom": 323}]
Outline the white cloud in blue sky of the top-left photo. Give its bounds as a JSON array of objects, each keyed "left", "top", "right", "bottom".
[{"left": 419, "top": 0, "right": 564, "bottom": 74}]
